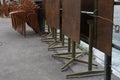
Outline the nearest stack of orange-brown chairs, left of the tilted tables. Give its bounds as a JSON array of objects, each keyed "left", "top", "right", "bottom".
[{"left": 9, "top": 0, "right": 40, "bottom": 36}]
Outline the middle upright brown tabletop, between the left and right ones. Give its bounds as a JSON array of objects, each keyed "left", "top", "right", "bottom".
[{"left": 62, "top": 0, "right": 81, "bottom": 43}]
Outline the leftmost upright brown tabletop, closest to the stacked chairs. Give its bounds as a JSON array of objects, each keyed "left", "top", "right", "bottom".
[{"left": 45, "top": 0, "right": 60, "bottom": 28}]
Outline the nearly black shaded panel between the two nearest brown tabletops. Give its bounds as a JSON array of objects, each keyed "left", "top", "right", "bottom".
[{"left": 80, "top": 0, "right": 96, "bottom": 37}]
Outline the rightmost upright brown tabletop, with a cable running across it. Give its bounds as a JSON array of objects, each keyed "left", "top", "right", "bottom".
[{"left": 96, "top": 0, "right": 114, "bottom": 55}]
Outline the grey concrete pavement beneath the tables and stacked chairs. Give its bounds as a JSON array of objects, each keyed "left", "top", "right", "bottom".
[{"left": 0, "top": 18, "right": 120, "bottom": 80}]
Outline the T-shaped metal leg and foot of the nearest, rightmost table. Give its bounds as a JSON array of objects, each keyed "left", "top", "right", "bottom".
[{"left": 66, "top": 20, "right": 104, "bottom": 78}]
